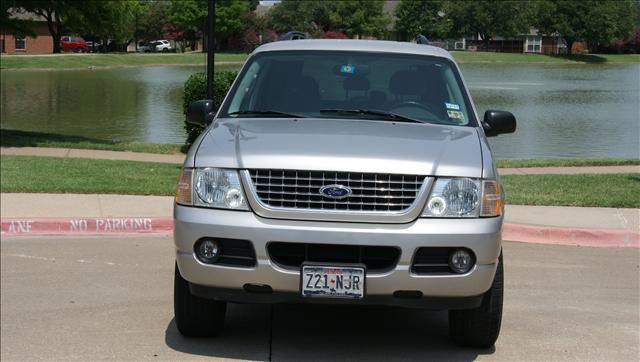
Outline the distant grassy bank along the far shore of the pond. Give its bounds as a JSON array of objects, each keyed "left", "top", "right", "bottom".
[{"left": 0, "top": 52, "right": 640, "bottom": 70}]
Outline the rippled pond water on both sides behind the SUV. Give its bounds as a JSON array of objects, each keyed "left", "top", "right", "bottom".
[{"left": 0, "top": 64, "right": 640, "bottom": 159}]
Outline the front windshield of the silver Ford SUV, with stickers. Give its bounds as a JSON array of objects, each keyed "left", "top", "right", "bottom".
[{"left": 221, "top": 51, "right": 474, "bottom": 125}]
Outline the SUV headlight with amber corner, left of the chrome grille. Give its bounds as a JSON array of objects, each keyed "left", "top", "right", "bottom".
[{"left": 176, "top": 167, "right": 249, "bottom": 210}]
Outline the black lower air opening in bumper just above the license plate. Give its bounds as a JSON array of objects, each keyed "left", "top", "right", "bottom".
[{"left": 267, "top": 242, "right": 400, "bottom": 273}]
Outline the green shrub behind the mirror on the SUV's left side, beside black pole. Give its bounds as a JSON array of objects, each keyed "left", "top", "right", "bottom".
[{"left": 182, "top": 71, "right": 238, "bottom": 146}]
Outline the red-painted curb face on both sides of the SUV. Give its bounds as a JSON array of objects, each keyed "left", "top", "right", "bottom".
[{"left": 0, "top": 217, "right": 640, "bottom": 249}]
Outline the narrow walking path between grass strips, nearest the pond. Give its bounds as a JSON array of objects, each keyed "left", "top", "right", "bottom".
[{"left": 0, "top": 147, "right": 640, "bottom": 175}]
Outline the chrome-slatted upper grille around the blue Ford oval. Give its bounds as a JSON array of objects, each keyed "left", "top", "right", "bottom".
[{"left": 249, "top": 170, "right": 425, "bottom": 213}]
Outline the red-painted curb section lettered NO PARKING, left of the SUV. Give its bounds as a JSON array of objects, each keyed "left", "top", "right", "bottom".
[{"left": 0, "top": 217, "right": 173, "bottom": 236}]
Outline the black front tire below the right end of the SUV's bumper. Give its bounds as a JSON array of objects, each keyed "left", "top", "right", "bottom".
[{"left": 449, "top": 252, "right": 504, "bottom": 348}]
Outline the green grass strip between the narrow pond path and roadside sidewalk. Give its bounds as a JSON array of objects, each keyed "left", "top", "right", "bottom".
[{"left": 0, "top": 156, "right": 640, "bottom": 208}]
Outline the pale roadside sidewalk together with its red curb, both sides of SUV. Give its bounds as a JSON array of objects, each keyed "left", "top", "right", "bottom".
[{"left": 0, "top": 193, "right": 640, "bottom": 248}]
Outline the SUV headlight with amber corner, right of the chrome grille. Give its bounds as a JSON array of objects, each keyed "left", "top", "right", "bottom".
[{"left": 422, "top": 178, "right": 502, "bottom": 217}]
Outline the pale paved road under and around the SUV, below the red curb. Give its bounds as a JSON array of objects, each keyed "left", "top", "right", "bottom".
[{"left": 0, "top": 237, "right": 640, "bottom": 361}]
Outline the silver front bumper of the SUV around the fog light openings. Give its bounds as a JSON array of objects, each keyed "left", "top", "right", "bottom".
[{"left": 174, "top": 205, "right": 502, "bottom": 305}]
